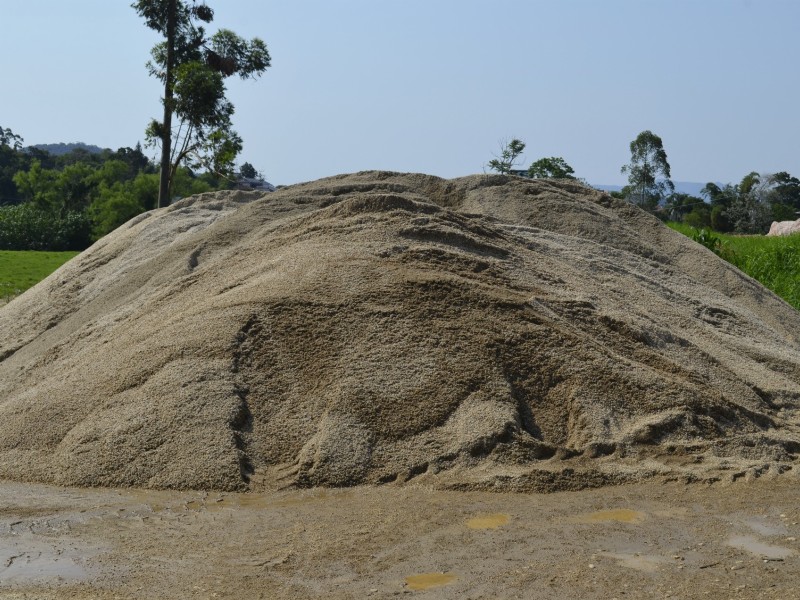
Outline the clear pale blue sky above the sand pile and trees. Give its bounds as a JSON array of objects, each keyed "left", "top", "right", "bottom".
[{"left": 0, "top": 0, "right": 800, "bottom": 184}]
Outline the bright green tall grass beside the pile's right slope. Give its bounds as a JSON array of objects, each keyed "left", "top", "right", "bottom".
[{"left": 668, "top": 223, "right": 800, "bottom": 310}]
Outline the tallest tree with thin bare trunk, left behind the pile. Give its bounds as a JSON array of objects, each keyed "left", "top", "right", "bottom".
[{"left": 132, "top": 0, "right": 271, "bottom": 206}]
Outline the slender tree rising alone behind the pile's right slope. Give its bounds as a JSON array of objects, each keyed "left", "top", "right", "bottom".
[{"left": 621, "top": 131, "right": 675, "bottom": 210}]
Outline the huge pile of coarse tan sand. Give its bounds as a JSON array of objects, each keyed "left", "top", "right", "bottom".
[{"left": 0, "top": 172, "right": 800, "bottom": 490}]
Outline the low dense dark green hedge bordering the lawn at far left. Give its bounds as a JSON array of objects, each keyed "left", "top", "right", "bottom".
[{"left": 0, "top": 203, "right": 91, "bottom": 250}]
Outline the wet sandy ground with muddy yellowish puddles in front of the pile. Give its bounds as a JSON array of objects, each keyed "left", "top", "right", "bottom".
[{"left": 0, "top": 475, "right": 800, "bottom": 600}]
